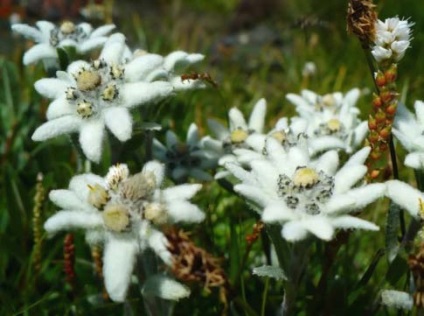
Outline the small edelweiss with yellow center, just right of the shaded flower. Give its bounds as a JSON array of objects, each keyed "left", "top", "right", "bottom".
[{"left": 204, "top": 99, "right": 266, "bottom": 164}]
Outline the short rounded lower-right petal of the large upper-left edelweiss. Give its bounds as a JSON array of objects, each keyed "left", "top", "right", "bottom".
[{"left": 103, "top": 107, "right": 132, "bottom": 142}]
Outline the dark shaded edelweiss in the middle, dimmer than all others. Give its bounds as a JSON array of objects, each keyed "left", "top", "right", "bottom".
[{"left": 153, "top": 123, "right": 218, "bottom": 183}]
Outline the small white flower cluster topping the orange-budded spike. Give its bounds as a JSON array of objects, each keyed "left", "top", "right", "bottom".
[{"left": 371, "top": 17, "right": 414, "bottom": 63}]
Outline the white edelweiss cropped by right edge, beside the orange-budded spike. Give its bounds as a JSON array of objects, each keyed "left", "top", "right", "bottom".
[{"left": 393, "top": 101, "right": 424, "bottom": 169}]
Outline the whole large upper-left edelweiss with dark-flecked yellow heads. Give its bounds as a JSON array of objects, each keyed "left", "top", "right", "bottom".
[{"left": 32, "top": 34, "right": 172, "bottom": 162}]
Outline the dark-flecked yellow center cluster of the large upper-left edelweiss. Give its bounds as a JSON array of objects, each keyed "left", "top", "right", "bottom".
[{"left": 65, "top": 59, "right": 125, "bottom": 119}]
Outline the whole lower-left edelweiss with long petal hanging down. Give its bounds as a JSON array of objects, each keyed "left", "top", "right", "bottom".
[{"left": 44, "top": 161, "right": 204, "bottom": 302}]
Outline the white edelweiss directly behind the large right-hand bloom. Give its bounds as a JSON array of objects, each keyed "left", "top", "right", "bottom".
[{"left": 286, "top": 88, "right": 368, "bottom": 153}]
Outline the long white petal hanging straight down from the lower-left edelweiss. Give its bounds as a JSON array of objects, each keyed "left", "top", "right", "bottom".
[{"left": 103, "top": 237, "right": 138, "bottom": 302}]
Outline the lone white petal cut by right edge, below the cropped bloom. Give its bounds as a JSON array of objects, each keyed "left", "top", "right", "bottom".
[{"left": 386, "top": 180, "right": 424, "bottom": 218}]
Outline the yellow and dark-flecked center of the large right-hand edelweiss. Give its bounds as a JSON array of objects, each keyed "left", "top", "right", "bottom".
[{"left": 277, "top": 167, "right": 334, "bottom": 215}]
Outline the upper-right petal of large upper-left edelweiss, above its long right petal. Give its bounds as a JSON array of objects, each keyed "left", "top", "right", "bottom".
[{"left": 125, "top": 54, "right": 163, "bottom": 82}]
